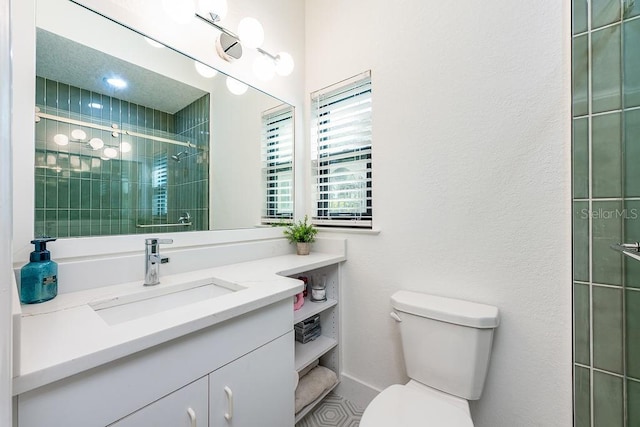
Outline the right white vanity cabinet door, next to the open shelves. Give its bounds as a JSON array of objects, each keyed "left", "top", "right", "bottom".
[{"left": 209, "top": 331, "right": 297, "bottom": 427}]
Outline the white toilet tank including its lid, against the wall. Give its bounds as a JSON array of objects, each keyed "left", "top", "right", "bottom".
[{"left": 391, "top": 291, "right": 499, "bottom": 400}]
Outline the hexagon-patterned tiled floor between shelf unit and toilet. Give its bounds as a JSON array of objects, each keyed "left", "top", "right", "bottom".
[{"left": 296, "top": 393, "right": 362, "bottom": 427}]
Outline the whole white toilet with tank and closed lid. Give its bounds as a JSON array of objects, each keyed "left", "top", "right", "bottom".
[{"left": 360, "top": 291, "right": 499, "bottom": 427}]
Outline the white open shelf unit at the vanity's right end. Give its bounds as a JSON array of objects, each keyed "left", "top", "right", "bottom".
[{"left": 292, "top": 264, "right": 340, "bottom": 423}]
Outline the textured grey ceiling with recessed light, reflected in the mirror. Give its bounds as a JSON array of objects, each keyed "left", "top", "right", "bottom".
[{"left": 36, "top": 28, "right": 205, "bottom": 114}]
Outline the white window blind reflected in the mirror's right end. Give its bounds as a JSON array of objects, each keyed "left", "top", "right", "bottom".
[{"left": 261, "top": 105, "right": 294, "bottom": 223}]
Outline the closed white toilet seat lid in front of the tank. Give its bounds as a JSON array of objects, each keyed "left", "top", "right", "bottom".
[{"left": 360, "top": 384, "right": 473, "bottom": 427}]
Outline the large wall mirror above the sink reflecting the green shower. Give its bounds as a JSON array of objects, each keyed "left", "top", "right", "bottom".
[{"left": 35, "top": 1, "right": 293, "bottom": 238}]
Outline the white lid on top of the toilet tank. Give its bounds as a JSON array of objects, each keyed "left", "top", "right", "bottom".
[{"left": 391, "top": 291, "right": 500, "bottom": 329}]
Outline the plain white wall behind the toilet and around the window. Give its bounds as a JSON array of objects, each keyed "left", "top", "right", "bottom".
[{"left": 305, "top": 0, "right": 572, "bottom": 427}]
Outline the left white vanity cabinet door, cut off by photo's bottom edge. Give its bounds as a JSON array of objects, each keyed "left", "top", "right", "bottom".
[{"left": 111, "top": 377, "right": 209, "bottom": 427}]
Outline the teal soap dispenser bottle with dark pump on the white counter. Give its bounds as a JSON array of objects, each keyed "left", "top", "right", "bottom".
[{"left": 20, "top": 238, "right": 58, "bottom": 304}]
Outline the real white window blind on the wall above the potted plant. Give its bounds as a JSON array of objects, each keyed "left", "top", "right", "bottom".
[{"left": 311, "top": 71, "right": 372, "bottom": 228}]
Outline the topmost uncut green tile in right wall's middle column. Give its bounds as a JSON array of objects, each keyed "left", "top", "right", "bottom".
[{"left": 591, "top": 25, "right": 622, "bottom": 113}]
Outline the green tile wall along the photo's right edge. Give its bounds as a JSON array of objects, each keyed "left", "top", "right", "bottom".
[{"left": 572, "top": 5, "right": 640, "bottom": 427}]
